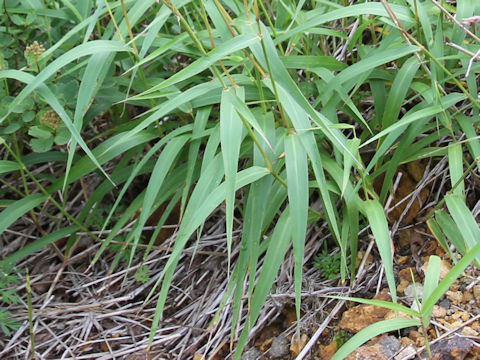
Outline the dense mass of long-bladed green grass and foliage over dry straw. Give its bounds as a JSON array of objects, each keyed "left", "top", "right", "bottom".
[{"left": 0, "top": 0, "right": 480, "bottom": 359}]
